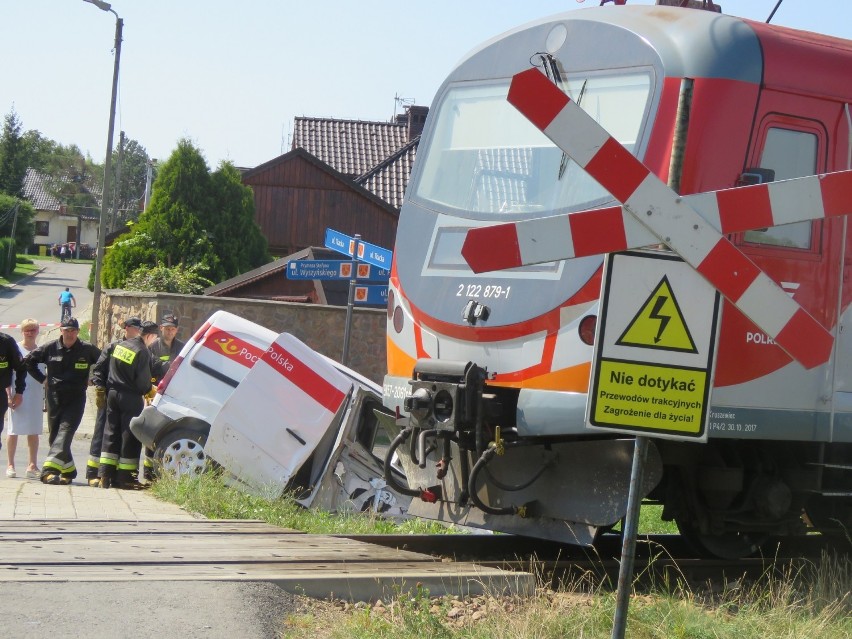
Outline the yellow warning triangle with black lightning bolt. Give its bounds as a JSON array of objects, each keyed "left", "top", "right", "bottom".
[{"left": 616, "top": 275, "right": 698, "bottom": 353}]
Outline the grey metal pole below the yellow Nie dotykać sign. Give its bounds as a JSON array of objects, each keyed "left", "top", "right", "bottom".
[{"left": 612, "top": 435, "right": 648, "bottom": 639}]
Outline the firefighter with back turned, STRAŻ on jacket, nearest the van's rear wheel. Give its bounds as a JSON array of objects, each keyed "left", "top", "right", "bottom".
[{"left": 98, "top": 322, "right": 159, "bottom": 490}]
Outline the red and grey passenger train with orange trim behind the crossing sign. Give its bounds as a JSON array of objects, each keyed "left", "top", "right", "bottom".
[{"left": 383, "top": 1, "right": 852, "bottom": 558}]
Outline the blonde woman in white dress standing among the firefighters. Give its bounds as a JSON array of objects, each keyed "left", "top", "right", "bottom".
[{"left": 6, "top": 319, "right": 44, "bottom": 479}]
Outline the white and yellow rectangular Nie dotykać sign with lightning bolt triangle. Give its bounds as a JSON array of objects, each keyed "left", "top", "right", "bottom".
[{"left": 586, "top": 251, "right": 720, "bottom": 442}]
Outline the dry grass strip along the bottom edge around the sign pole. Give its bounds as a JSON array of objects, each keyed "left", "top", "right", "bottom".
[{"left": 281, "top": 557, "right": 852, "bottom": 639}]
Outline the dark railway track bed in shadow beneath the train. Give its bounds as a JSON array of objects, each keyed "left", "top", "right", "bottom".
[{"left": 348, "top": 535, "right": 852, "bottom": 587}]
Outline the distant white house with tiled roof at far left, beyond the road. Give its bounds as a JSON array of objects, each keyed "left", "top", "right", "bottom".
[{"left": 23, "top": 168, "right": 100, "bottom": 255}]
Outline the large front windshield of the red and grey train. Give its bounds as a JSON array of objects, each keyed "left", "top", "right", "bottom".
[{"left": 415, "top": 70, "right": 652, "bottom": 219}]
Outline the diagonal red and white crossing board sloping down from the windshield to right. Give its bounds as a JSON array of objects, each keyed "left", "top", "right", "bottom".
[{"left": 466, "top": 69, "right": 834, "bottom": 368}]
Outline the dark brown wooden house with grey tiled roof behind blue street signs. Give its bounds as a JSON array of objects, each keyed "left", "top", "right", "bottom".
[{"left": 223, "top": 106, "right": 429, "bottom": 304}]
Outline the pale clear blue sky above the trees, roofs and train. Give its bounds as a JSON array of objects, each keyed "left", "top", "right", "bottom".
[{"left": 0, "top": 0, "right": 852, "bottom": 168}]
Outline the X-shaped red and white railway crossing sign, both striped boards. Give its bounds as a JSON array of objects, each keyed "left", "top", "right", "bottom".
[{"left": 463, "top": 69, "right": 852, "bottom": 368}]
